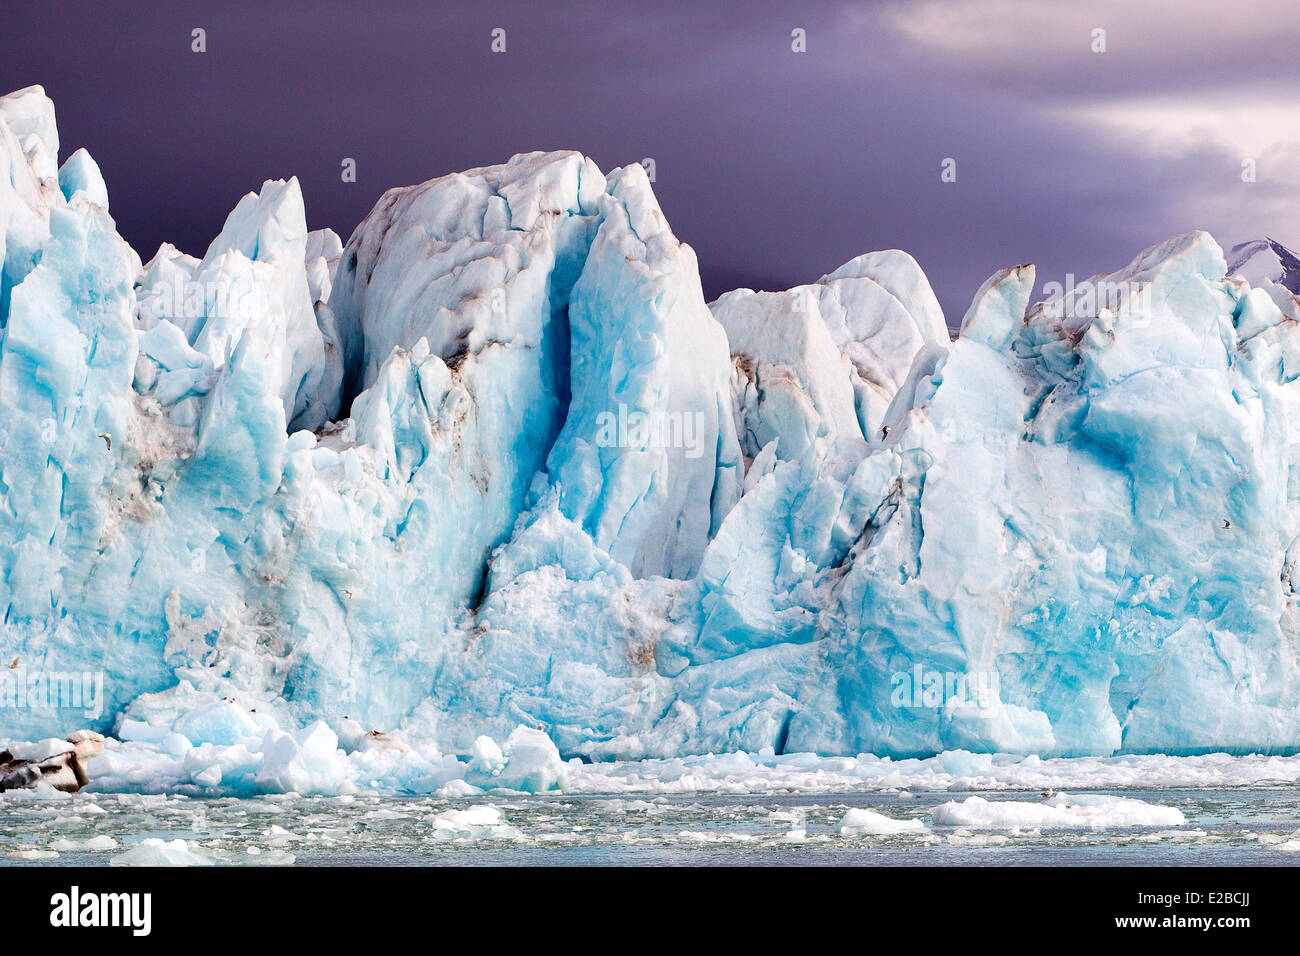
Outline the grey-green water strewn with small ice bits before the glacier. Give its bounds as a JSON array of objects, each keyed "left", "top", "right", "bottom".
[{"left": 0, "top": 788, "right": 1300, "bottom": 866}]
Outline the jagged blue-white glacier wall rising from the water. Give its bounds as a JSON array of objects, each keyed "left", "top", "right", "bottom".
[{"left": 0, "top": 87, "right": 1300, "bottom": 792}]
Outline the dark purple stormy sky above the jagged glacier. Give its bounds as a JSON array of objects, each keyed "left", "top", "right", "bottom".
[{"left": 0, "top": 0, "right": 1300, "bottom": 325}]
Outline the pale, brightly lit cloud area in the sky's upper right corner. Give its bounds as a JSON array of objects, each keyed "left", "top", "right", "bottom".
[{"left": 848, "top": 0, "right": 1300, "bottom": 261}]
